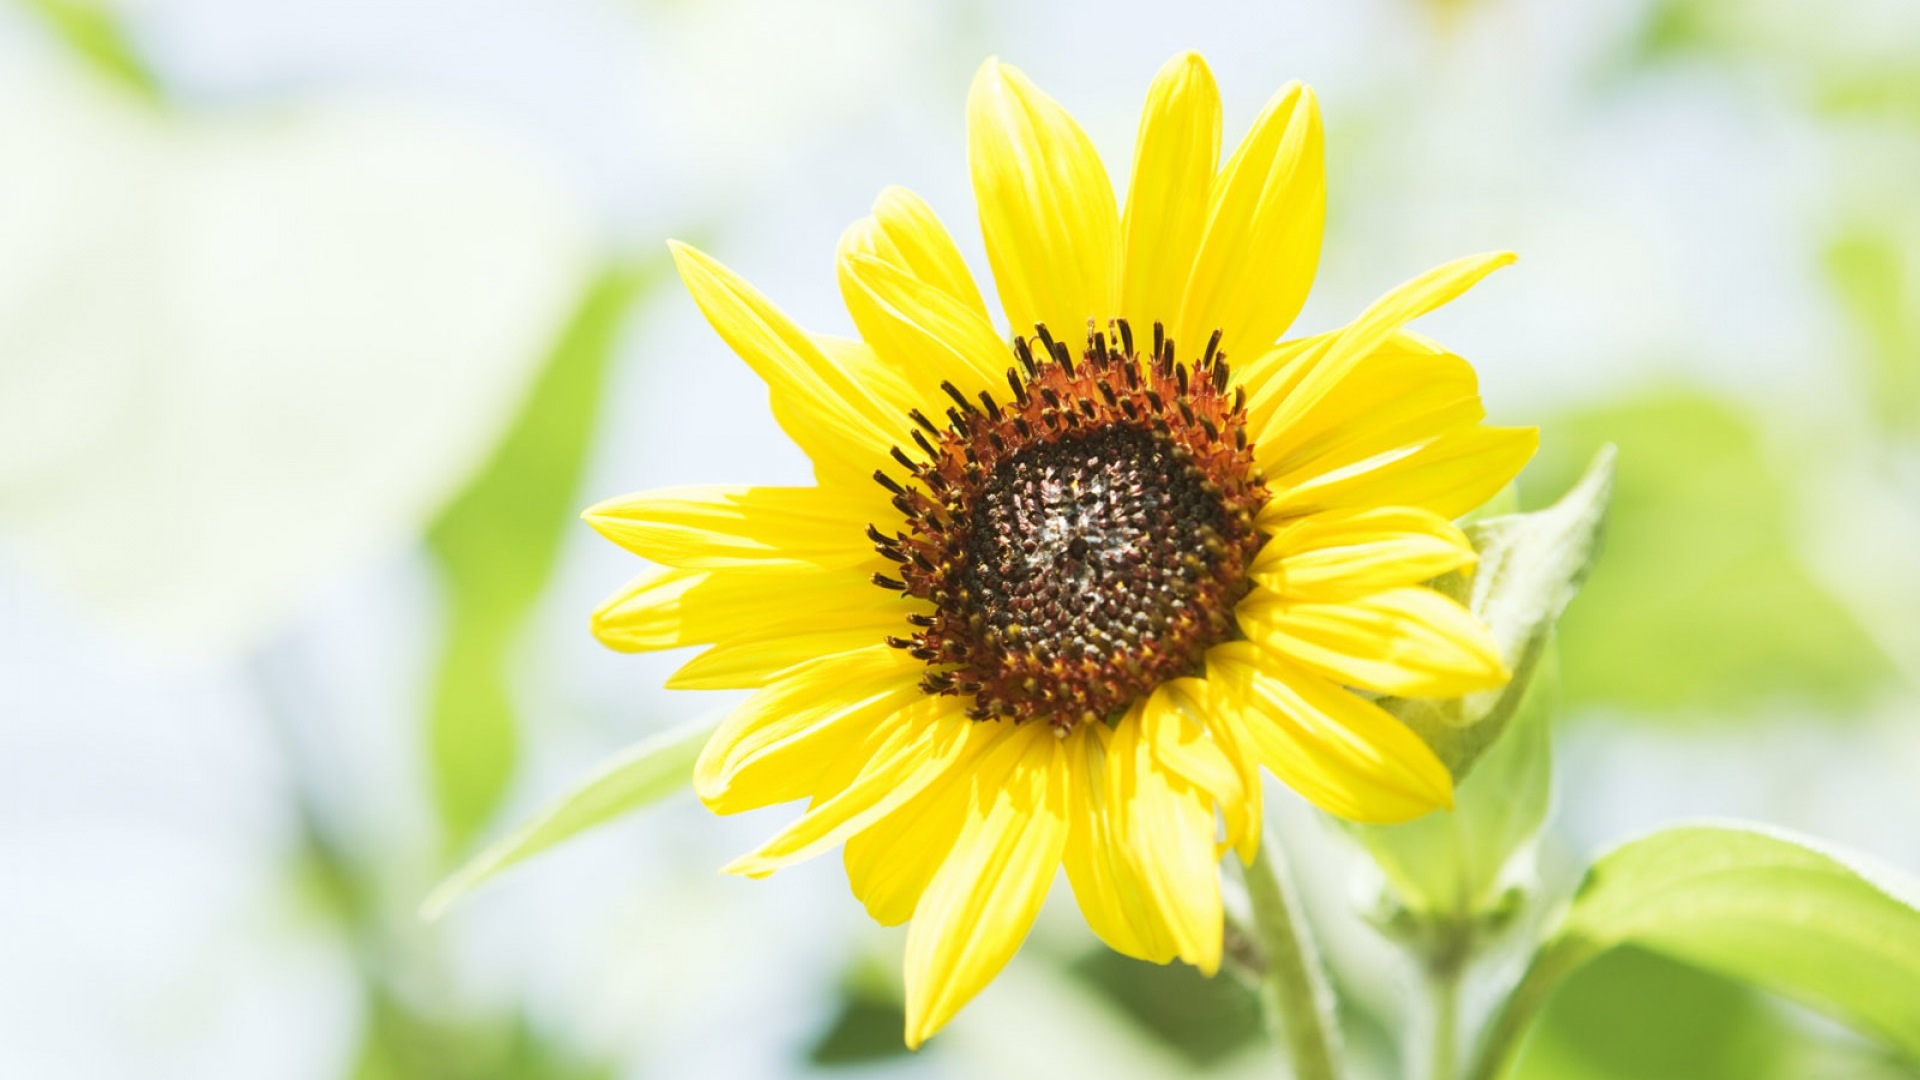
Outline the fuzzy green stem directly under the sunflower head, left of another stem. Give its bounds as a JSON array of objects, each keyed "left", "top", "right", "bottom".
[{"left": 1244, "top": 838, "right": 1340, "bottom": 1080}]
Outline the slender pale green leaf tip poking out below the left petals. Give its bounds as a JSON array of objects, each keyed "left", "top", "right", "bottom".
[{"left": 420, "top": 719, "right": 720, "bottom": 920}]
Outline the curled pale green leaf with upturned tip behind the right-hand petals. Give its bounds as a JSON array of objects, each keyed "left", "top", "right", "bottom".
[{"left": 1382, "top": 446, "right": 1615, "bottom": 778}]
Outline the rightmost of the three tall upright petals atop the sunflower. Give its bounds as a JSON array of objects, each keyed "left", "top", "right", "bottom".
[{"left": 1177, "top": 83, "right": 1327, "bottom": 357}]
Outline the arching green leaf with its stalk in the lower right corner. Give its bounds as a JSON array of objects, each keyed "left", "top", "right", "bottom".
[{"left": 1473, "top": 824, "right": 1920, "bottom": 1080}]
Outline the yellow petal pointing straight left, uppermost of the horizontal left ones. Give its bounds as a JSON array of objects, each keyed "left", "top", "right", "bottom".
[{"left": 580, "top": 486, "right": 876, "bottom": 571}]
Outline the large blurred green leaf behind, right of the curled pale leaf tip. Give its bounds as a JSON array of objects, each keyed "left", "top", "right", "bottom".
[{"left": 1524, "top": 394, "right": 1891, "bottom": 721}]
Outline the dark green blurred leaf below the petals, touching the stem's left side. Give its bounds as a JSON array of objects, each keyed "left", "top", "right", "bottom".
[{"left": 1068, "top": 949, "right": 1261, "bottom": 1068}]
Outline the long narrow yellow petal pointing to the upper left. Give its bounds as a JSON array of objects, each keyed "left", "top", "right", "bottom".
[{"left": 668, "top": 242, "right": 900, "bottom": 479}]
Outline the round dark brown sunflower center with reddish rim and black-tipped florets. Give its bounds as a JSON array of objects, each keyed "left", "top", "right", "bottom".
[{"left": 868, "top": 315, "right": 1265, "bottom": 730}]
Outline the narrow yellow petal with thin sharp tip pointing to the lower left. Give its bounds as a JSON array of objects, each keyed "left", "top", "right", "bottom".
[{"left": 722, "top": 696, "right": 983, "bottom": 878}]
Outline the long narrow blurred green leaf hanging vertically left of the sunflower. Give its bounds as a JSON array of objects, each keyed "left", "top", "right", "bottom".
[{"left": 426, "top": 265, "right": 660, "bottom": 853}]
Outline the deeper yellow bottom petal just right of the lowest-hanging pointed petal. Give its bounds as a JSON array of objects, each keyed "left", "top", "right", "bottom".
[{"left": 1066, "top": 709, "right": 1179, "bottom": 963}]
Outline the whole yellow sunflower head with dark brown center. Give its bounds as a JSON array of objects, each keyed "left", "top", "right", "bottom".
[{"left": 586, "top": 54, "right": 1536, "bottom": 1045}]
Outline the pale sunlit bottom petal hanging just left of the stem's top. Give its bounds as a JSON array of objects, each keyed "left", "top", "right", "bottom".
[{"left": 1121, "top": 688, "right": 1225, "bottom": 974}]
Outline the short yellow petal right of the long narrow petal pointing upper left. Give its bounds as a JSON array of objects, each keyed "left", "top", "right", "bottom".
[{"left": 839, "top": 250, "right": 1012, "bottom": 399}]
